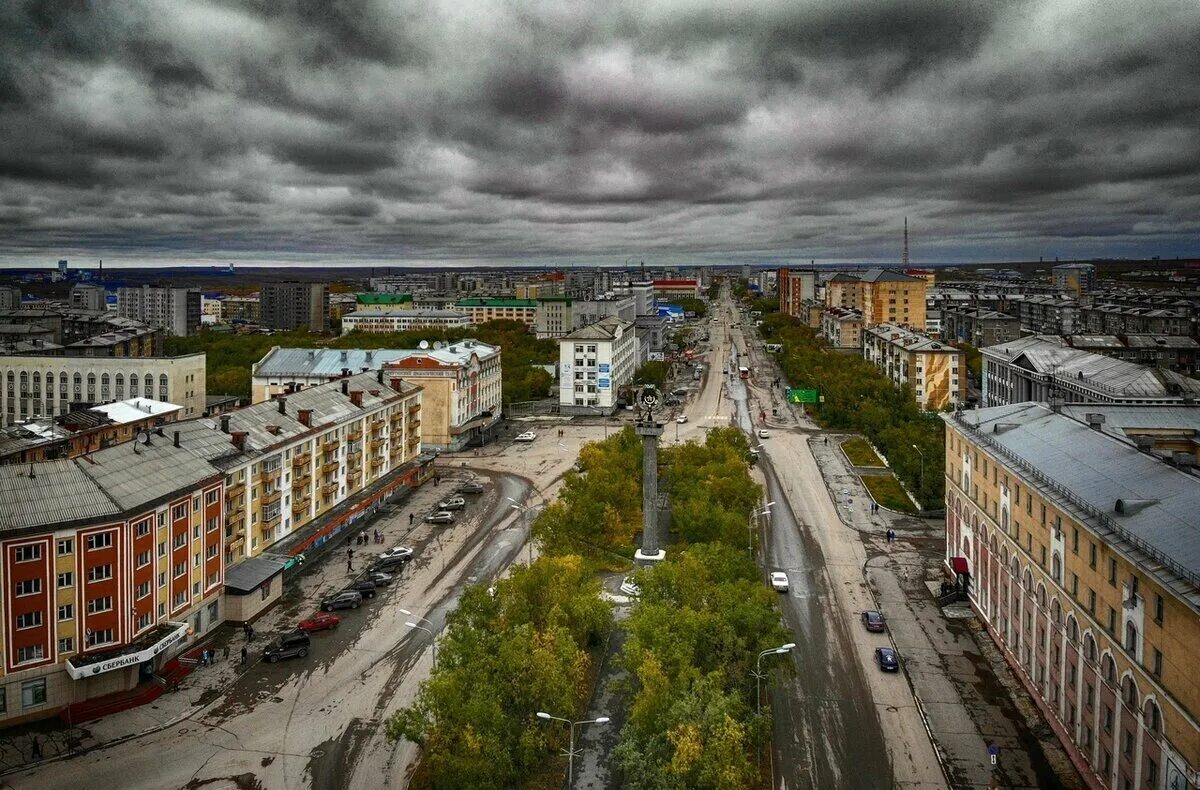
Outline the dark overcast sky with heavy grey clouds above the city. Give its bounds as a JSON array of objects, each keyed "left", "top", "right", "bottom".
[{"left": 0, "top": 0, "right": 1200, "bottom": 265}]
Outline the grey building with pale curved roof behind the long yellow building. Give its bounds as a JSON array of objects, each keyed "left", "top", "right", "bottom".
[{"left": 979, "top": 335, "right": 1200, "bottom": 406}]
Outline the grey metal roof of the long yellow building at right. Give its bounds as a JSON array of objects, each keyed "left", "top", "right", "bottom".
[{"left": 946, "top": 403, "right": 1200, "bottom": 605}]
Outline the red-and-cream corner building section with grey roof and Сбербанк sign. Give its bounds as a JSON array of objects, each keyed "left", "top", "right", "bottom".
[{"left": 0, "top": 435, "right": 224, "bottom": 725}]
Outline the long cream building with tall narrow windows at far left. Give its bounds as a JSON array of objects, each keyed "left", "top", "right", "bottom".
[{"left": 0, "top": 354, "right": 205, "bottom": 426}]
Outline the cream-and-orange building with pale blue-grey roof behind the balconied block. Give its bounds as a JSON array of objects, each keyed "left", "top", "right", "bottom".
[{"left": 251, "top": 340, "right": 502, "bottom": 450}]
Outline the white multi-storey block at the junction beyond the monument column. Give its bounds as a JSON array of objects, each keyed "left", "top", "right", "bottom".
[{"left": 558, "top": 317, "right": 637, "bottom": 414}]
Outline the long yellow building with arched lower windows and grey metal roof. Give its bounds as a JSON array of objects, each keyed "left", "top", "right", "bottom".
[{"left": 943, "top": 403, "right": 1200, "bottom": 789}]
